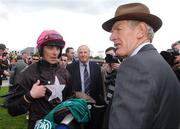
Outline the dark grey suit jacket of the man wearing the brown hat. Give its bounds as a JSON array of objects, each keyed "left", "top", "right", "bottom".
[{"left": 109, "top": 44, "right": 180, "bottom": 129}]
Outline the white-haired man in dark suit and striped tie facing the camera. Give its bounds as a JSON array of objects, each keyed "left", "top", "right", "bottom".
[{"left": 66, "top": 45, "right": 103, "bottom": 129}]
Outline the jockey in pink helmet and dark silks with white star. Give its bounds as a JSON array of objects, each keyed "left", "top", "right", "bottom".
[{"left": 7, "top": 30, "right": 68, "bottom": 129}]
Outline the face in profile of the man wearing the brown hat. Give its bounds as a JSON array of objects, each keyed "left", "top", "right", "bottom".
[{"left": 110, "top": 20, "right": 141, "bottom": 57}]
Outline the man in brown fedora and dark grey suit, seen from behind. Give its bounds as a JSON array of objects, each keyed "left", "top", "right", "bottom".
[{"left": 102, "top": 3, "right": 180, "bottom": 129}]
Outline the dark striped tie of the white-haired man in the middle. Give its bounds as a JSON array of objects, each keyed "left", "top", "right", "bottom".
[{"left": 83, "top": 64, "right": 90, "bottom": 94}]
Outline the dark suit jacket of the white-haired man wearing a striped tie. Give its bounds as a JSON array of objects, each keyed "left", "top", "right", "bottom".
[{"left": 66, "top": 61, "right": 103, "bottom": 104}]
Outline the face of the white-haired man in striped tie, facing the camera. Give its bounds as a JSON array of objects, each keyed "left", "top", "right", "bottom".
[{"left": 78, "top": 46, "right": 90, "bottom": 63}]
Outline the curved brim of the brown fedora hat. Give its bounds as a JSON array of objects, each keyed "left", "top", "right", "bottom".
[{"left": 102, "top": 13, "right": 162, "bottom": 32}]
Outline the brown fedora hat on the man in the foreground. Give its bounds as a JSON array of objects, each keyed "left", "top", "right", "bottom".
[{"left": 102, "top": 3, "right": 162, "bottom": 32}]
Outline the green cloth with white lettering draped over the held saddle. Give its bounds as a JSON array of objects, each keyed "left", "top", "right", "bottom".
[{"left": 34, "top": 98, "right": 91, "bottom": 129}]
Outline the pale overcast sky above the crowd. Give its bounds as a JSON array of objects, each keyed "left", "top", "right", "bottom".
[{"left": 0, "top": 0, "right": 180, "bottom": 55}]
